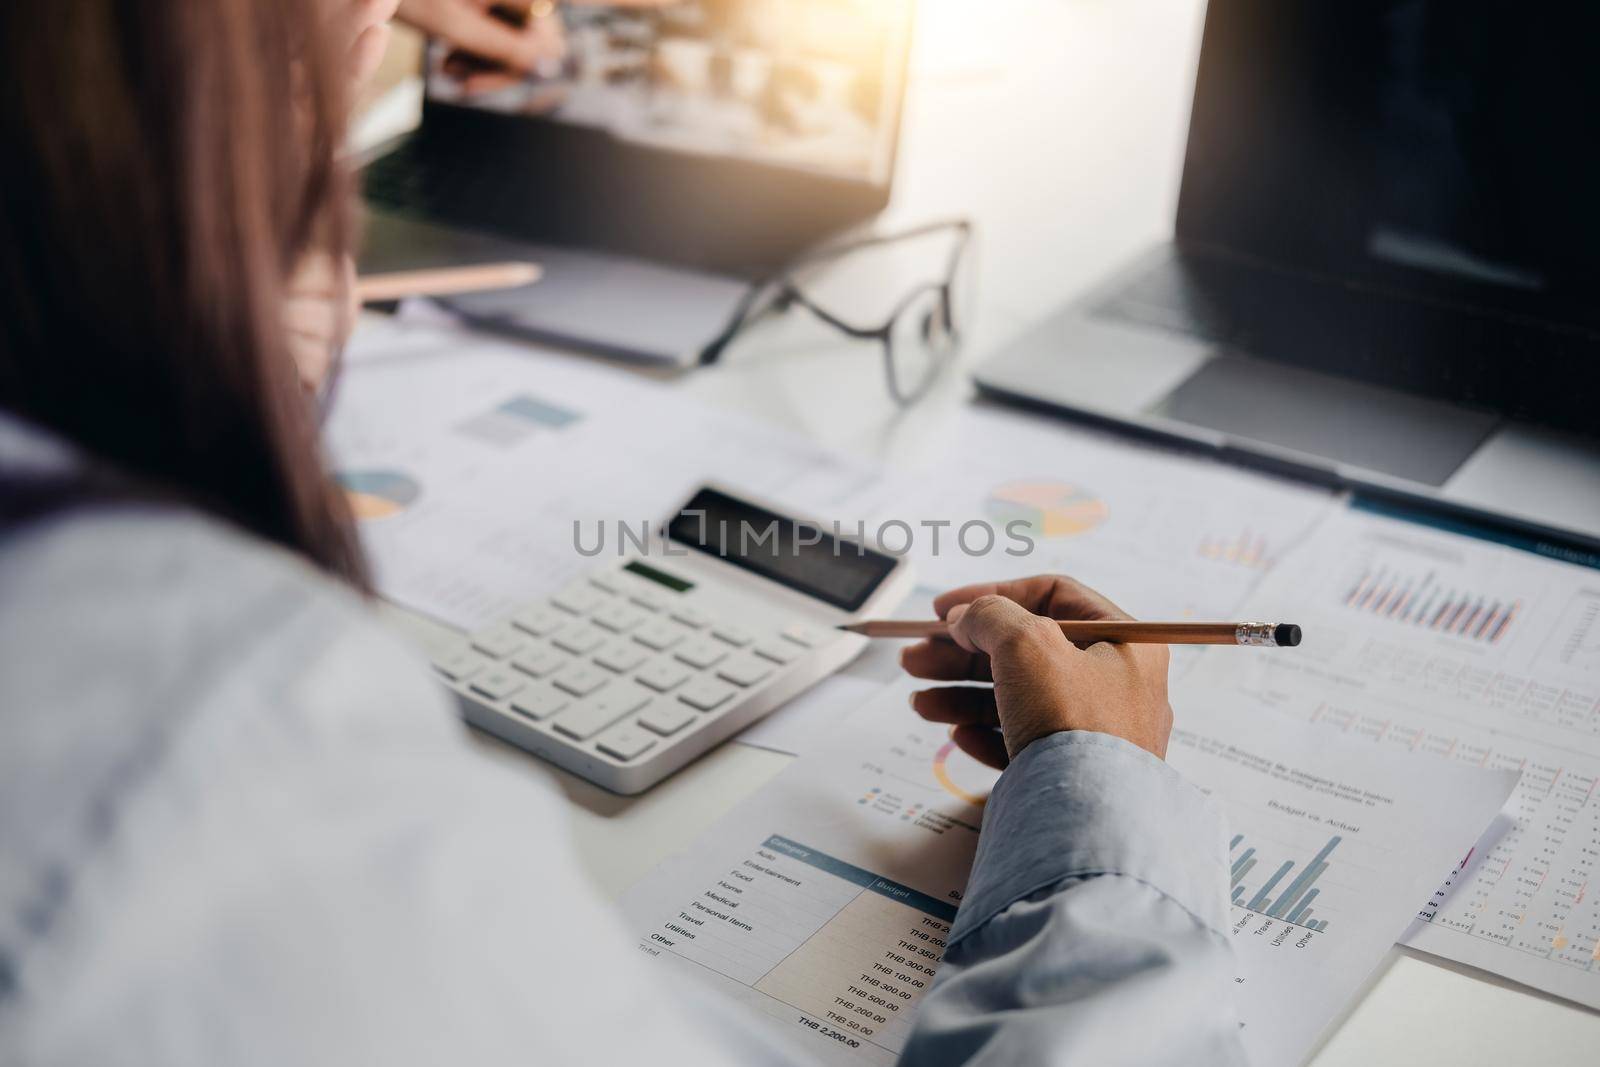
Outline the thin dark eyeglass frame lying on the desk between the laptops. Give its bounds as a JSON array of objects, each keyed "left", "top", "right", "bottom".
[{"left": 699, "top": 219, "right": 974, "bottom": 406}]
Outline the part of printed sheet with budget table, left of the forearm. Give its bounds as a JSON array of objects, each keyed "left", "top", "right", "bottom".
[{"left": 622, "top": 688, "right": 995, "bottom": 1064}]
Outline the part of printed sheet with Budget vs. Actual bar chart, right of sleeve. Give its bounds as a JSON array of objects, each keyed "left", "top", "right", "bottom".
[{"left": 1166, "top": 703, "right": 1517, "bottom": 1064}]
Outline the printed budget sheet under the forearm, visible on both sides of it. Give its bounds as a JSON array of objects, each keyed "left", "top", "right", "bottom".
[{"left": 622, "top": 686, "right": 1515, "bottom": 1064}]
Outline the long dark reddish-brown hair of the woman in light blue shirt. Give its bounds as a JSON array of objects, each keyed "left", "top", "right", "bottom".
[{"left": 0, "top": 0, "right": 365, "bottom": 587}]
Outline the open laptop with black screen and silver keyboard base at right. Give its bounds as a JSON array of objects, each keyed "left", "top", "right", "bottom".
[{"left": 976, "top": 0, "right": 1600, "bottom": 549}]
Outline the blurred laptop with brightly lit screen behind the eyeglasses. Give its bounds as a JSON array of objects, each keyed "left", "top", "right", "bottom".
[{"left": 362, "top": 0, "right": 914, "bottom": 365}]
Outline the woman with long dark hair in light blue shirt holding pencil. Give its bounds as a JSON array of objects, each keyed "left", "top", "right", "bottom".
[{"left": 0, "top": 0, "right": 1242, "bottom": 1065}]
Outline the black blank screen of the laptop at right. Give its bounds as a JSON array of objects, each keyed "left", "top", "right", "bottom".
[{"left": 1178, "top": 0, "right": 1600, "bottom": 325}]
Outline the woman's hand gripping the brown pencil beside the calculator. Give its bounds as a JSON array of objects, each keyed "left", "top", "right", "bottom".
[{"left": 901, "top": 576, "right": 1173, "bottom": 768}]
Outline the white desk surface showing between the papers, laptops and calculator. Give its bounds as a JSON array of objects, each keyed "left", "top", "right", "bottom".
[{"left": 371, "top": 0, "right": 1600, "bottom": 1067}]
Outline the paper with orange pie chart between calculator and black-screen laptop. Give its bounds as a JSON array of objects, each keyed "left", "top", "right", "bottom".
[{"left": 837, "top": 408, "right": 1339, "bottom": 673}]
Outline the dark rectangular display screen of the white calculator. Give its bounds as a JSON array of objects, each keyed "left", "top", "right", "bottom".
[{"left": 667, "top": 490, "right": 894, "bottom": 611}]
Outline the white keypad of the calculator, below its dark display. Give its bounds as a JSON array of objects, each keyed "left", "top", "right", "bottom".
[{"left": 434, "top": 571, "right": 832, "bottom": 763}]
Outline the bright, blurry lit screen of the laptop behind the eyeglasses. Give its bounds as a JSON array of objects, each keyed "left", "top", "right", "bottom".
[{"left": 427, "top": 0, "right": 914, "bottom": 187}]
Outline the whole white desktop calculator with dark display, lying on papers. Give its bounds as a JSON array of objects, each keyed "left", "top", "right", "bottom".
[{"left": 434, "top": 486, "right": 912, "bottom": 793}]
